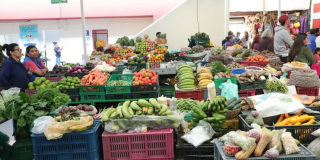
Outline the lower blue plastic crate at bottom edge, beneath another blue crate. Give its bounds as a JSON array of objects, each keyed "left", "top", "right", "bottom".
[{"left": 34, "top": 150, "right": 99, "bottom": 160}]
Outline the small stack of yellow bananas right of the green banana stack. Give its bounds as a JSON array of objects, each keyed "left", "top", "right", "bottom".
[{"left": 196, "top": 68, "right": 213, "bottom": 89}]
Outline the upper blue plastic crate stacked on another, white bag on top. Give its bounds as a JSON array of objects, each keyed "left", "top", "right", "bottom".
[{"left": 31, "top": 121, "right": 102, "bottom": 154}]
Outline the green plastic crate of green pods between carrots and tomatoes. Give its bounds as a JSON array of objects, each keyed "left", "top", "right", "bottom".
[{"left": 105, "top": 74, "right": 133, "bottom": 94}]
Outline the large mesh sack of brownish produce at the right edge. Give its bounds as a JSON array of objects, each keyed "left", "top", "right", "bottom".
[{"left": 287, "top": 70, "right": 320, "bottom": 87}]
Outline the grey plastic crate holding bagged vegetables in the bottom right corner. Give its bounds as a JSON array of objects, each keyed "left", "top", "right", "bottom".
[{"left": 214, "top": 139, "right": 316, "bottom": 160}]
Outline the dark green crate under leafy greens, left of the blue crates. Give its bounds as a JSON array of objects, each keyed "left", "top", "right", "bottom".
[{"left": 12, "top": 138, "right": 34, "bottom": 160}]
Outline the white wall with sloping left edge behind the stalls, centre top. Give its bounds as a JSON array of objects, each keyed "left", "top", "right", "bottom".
[{"left": 136, "top": 0, "right": 225, "bottom": 50}]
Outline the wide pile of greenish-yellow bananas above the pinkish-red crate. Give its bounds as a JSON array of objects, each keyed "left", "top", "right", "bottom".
[{"left": 101, "top": 98, "right": 172, "bottom": 122}]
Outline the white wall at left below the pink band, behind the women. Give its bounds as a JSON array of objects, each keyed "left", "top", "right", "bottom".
[{"left": 0, "top": 17, "right": 153, "bottom": 67}]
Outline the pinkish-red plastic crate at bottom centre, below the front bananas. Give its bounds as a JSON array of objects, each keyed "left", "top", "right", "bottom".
[{"left": 102, "top": 129, "right": 174, "bottom": 160}]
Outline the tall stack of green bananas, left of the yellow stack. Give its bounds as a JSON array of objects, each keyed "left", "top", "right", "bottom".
[{"left": 177, "top": 65, "right": 196, "bottom": 90}]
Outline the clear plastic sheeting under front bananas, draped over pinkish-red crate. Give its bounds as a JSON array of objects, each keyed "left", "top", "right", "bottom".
[{"left": 105, "top": 112, "right": 184, "bottom": 133}]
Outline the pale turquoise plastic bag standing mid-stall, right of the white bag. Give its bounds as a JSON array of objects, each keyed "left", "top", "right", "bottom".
[{"left": 219, "top": 79, "right": 239, "bottom": 99}]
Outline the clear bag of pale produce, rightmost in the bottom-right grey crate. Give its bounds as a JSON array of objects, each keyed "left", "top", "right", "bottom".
[{"left": 281, "top": 132, "right": 300, "bottom": 155}]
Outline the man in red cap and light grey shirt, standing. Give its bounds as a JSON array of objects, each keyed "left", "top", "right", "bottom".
[{"left": 274, "top": 15, "right": 293, "bottom": 63}]
